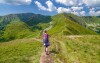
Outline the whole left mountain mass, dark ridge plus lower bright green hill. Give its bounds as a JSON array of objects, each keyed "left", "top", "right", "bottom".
[{"left": 0, "top": 13, "right": 51, "bottom": 40}]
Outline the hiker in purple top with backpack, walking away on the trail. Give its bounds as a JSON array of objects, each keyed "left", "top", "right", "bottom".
[{"left": 43, "top": 30, "right": 50, "bottom": 54}]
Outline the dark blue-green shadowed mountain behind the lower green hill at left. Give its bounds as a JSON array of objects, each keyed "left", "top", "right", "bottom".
[{"left": 0, "top": 13, "right": 51, "bottom": 33}]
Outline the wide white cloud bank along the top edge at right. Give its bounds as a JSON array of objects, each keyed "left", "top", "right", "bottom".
[{"left": 55, "top": 0, "right": 100, "bottom": 7}]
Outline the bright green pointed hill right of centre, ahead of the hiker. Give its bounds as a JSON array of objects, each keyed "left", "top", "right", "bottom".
[{"left": 49, "top": 14, "right": 96, "bottom": 35}]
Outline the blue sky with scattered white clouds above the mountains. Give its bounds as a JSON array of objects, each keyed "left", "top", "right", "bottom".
[{"left": 0, "top": 0, "right": 100, "bottom": 16}]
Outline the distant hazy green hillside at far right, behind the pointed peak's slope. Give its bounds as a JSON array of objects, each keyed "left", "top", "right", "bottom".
[{"left": 63, "top": 13, "right": 100, "bottom": 33}]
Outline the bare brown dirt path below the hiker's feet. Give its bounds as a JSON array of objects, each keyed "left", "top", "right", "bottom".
[{"left": 40, "top": 51, "right": 54, "bottom": 63}]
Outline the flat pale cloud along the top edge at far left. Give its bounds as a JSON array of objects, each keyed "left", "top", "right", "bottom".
[{"left": 0, "top": 0, "right": 32, "bottom": 5}]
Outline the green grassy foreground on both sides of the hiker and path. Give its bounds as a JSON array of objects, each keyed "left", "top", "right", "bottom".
[{"left": 0, "top": 35, "right": 100, "bottom": 63}]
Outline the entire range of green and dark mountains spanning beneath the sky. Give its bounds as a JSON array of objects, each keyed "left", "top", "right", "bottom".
[{"left": 0, "top": 13, "right": 100, "bottom": 40}]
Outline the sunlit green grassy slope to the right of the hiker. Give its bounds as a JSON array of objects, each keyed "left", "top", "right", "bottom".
[{"left": 50, "top": 35, "right": 100, "bottom": 63}]
